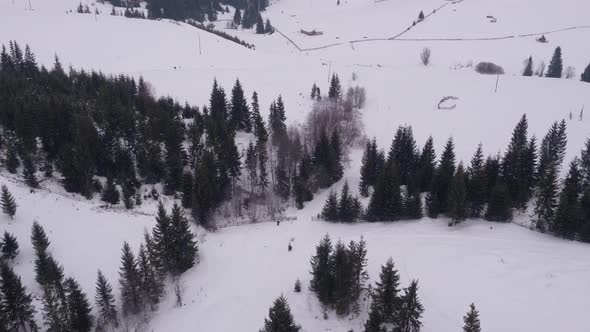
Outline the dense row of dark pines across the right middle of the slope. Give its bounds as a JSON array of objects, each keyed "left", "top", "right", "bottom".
[{"left": 322, "top": 115, "right": 590, "bottom": 241}]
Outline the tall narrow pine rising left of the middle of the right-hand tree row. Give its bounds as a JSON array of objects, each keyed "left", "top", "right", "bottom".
[{"left": 426, "top": 137, "right": 455, "bottom": 218}]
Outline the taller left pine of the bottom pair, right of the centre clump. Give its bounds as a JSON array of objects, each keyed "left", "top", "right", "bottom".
[{"left": 365, "top": 258, "right": 400, "bottom": 331}]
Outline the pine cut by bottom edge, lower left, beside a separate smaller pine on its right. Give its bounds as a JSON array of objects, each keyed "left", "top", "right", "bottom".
[{"left": 64, "top": 278, "right": 94, "bottom": 332}]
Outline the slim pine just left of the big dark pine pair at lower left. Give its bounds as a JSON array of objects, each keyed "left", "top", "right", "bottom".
[{"left": 119, "top": 242, "right": 141, "bottom": 316}]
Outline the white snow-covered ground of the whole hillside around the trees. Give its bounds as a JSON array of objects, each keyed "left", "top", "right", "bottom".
[{"left": 0, "top": 0, "right": 590, "bottom": 332}]
